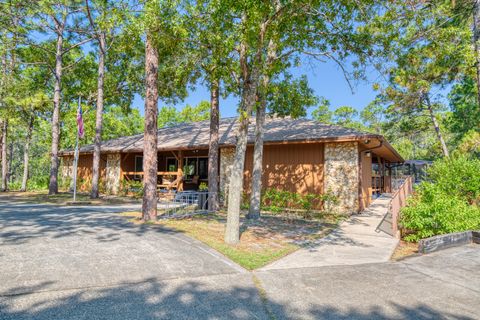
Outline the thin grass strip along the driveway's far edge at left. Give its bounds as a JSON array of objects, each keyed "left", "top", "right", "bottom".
[{"left": 0, "top": 190, "right": 140, "bottom": 205}]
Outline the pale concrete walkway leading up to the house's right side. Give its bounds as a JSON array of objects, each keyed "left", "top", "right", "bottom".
[{"left": 262, "top": 195, "right": 398, "bottom": 270}]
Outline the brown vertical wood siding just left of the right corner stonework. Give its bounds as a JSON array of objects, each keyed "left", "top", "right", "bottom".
[{"left": 244, "top": 143, "right": 324, "bottom": 194}]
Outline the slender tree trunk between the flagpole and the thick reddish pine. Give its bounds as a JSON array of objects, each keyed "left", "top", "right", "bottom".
[{"left": 90, "top": 33, "right": 106, "bottom": 199}]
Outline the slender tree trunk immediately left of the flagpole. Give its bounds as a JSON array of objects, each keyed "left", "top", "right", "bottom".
[{"left": 48, "top": 34, "right": 63, "bottom": 194}]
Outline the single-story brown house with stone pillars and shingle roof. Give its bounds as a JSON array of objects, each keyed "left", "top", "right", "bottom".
[{"left": 61, "top": 117, "right": 404, "bottom": 213}]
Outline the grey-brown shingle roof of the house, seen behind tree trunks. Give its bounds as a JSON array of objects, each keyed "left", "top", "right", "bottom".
[{"left": 62, "top": 117, "right": 381, "bottom": 154}]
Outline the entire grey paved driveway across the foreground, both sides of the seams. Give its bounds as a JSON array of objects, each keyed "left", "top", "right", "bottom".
[{"left": 0, "top": 202, "right": 480, "bottom": 320}]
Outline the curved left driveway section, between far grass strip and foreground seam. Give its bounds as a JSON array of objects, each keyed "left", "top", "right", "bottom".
[{"left": 0, "top": 202, "right": 244, "bottom": 295}]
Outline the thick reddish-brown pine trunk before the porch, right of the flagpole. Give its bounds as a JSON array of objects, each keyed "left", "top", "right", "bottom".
[{"left": 142, "top": 33, "right": 158, "bottom": 221}]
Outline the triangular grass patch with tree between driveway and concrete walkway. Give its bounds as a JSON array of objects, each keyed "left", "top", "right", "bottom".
[{"left": 121, "top": 212, "right": 339, "bottom": 270}]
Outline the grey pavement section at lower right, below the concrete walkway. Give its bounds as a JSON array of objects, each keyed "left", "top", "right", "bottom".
[{"left": 256, "top": 245, "right": 480, "bottom": 320}]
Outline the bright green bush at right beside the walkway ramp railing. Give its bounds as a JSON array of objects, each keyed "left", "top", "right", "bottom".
[{"left": 401, "top": 156, "right": 480, "bottom": 241}]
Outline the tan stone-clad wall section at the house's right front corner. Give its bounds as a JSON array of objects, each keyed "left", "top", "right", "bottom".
[{"left": 324, "top": 142, "right": 359, "bottom": 214}]
